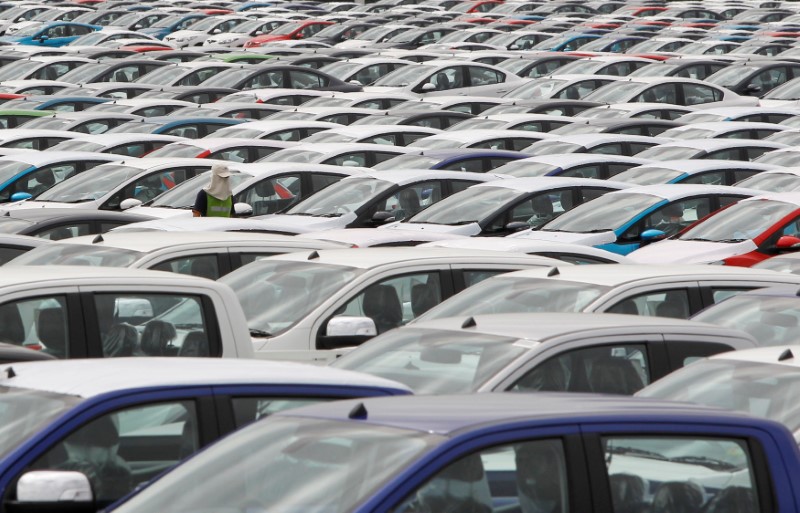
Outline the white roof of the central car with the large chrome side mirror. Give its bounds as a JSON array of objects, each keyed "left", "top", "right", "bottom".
[{"left": 264, "top": 247, "right": 569, "bottom": 270}]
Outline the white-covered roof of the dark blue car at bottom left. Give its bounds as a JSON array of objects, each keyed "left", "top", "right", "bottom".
[{"left": 0, "top": 357, "right": 408, "bottom": 397}]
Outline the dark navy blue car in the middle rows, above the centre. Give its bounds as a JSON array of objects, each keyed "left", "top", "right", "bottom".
[{"left": 372, "top": 146, "right": 530, "bottom": 173}]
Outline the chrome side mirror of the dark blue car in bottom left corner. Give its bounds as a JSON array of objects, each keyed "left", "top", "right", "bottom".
[{"left": 6, "top": 470, "right": 97, "bottom": 513}]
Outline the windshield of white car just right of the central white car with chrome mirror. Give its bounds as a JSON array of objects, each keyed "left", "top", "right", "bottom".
[{"left": 420, "top": 276, "right": 610, "bottom": 320}]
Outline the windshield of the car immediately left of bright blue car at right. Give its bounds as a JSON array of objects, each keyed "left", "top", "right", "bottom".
[{"left": 408, "top": 187, "right": 520, "bottom": 226}]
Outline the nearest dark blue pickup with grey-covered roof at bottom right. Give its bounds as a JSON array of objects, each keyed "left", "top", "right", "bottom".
[{"left": 103, "top": 392, "right": 800, "bottom": 513}]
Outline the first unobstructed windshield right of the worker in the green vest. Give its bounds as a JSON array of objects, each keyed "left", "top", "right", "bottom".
[{"left": 286, "top": 176, "right": 395, "bottom": 217}]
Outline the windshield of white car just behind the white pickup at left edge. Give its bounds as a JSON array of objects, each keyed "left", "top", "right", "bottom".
[{"left": 6, "top": 244, "right": 144, "bottom": 267}]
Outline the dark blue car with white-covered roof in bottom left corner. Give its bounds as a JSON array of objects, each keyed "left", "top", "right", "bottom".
[{"left": 0, "top": 356, "right": 409, "bottom": 511}]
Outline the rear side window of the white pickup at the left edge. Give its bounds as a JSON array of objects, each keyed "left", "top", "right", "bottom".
[{"left": 94, "top": 293, "right": 214, "bottom": 358}]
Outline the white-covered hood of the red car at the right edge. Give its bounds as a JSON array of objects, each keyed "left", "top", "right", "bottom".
[{"left": 628, "top": 240, "right": 757, "bottom": 264}]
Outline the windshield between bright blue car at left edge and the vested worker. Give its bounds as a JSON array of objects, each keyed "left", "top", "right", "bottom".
[{"left": 36, "top": 164, "right": 142, "bottom": 203}]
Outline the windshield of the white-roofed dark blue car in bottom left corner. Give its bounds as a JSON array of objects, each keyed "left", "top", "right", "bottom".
[{"left": 0, "top": 387, "right": 83, "bottom": 457}]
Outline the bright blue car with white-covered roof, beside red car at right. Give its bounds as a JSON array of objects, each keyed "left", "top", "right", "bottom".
[{"left": 510, "top": 184, "right": 761, "bottom": 255}]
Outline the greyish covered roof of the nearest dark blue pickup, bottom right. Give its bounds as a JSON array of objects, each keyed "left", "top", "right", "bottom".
[{"left": 275, "top": 392, "right": 764, "bottom": 435}]
